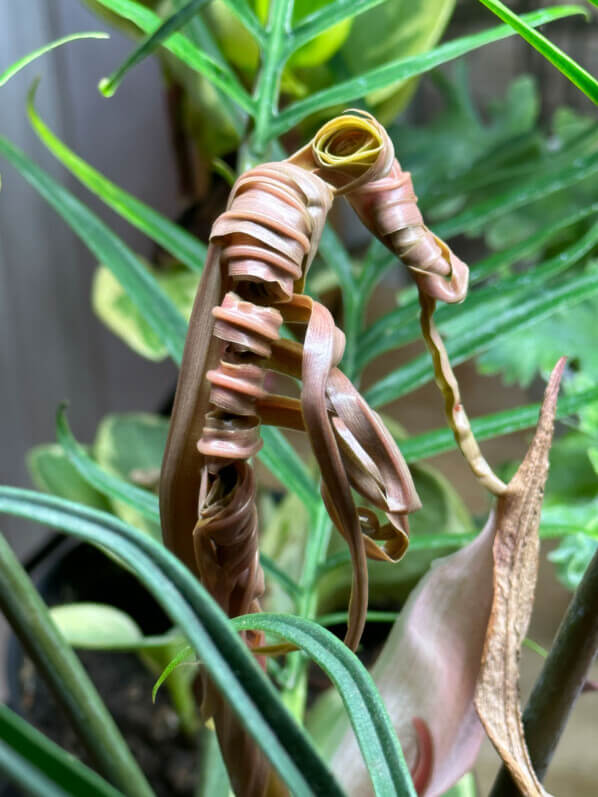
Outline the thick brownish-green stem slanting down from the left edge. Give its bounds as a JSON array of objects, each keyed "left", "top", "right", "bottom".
[{"left": 0, "top": 534, "right": 153, "bottom": 797}]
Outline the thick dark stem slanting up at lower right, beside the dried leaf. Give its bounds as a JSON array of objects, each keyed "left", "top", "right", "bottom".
[{"left": 490, "top": 552, "right": 598, "bottom": 797}]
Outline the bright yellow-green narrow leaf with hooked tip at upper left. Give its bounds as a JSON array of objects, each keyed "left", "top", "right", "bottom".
[{"left": 27, "top": 84, "right": 207, "bottom": 272}]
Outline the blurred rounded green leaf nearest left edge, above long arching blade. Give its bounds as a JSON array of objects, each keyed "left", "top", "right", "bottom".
[{"left": 27, "top": 443, "right": 109, "bottom": 509}]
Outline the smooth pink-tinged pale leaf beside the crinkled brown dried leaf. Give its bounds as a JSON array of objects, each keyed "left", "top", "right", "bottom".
[{"left": 332, "top": 506, "right": 496, "bottom": 797}]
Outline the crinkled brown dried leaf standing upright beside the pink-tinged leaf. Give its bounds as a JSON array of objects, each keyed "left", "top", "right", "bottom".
[{"left": 475, "top": 358, "right": 565, "bottom": 797}]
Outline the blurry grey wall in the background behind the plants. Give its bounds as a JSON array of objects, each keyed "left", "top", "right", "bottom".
[{"left": 0, "top": 0, "right": 598, "bottom": 553}]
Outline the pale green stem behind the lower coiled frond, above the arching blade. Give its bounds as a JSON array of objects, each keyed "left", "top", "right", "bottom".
[{"left": 282, "top": 503, "right": 330, "bottom": 720}]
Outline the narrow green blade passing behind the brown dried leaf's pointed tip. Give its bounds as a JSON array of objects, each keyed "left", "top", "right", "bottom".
[{"left": 399, "top": 386, "right": 598, "bottom": 462}]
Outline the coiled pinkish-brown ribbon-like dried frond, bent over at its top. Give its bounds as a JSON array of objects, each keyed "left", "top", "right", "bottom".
[{"left": 160, "top": 112, "right": 478, "bottom": 795}]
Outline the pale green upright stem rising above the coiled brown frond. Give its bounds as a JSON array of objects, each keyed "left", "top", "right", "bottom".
[{"left": 250, "top": 0, "right": 294, "bottom": 163}]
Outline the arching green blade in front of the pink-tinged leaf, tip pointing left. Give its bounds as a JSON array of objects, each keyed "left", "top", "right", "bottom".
[{"left": 232, "top": 613, "right": 415, "bottom": 797}]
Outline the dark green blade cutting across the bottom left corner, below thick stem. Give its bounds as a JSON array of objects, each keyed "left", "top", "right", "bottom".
[{"left": 0, "top": 705, "right": 121, "bottom": 797}]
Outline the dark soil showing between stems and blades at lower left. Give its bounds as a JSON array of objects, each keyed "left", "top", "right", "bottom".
[{"left": 0, "top": 546, "right": 197, "bottom": 797}]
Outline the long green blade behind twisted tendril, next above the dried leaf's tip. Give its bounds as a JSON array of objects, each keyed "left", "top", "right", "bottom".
[{"left": 366, "top": 273, "right": 598, "bottom": 407}]
